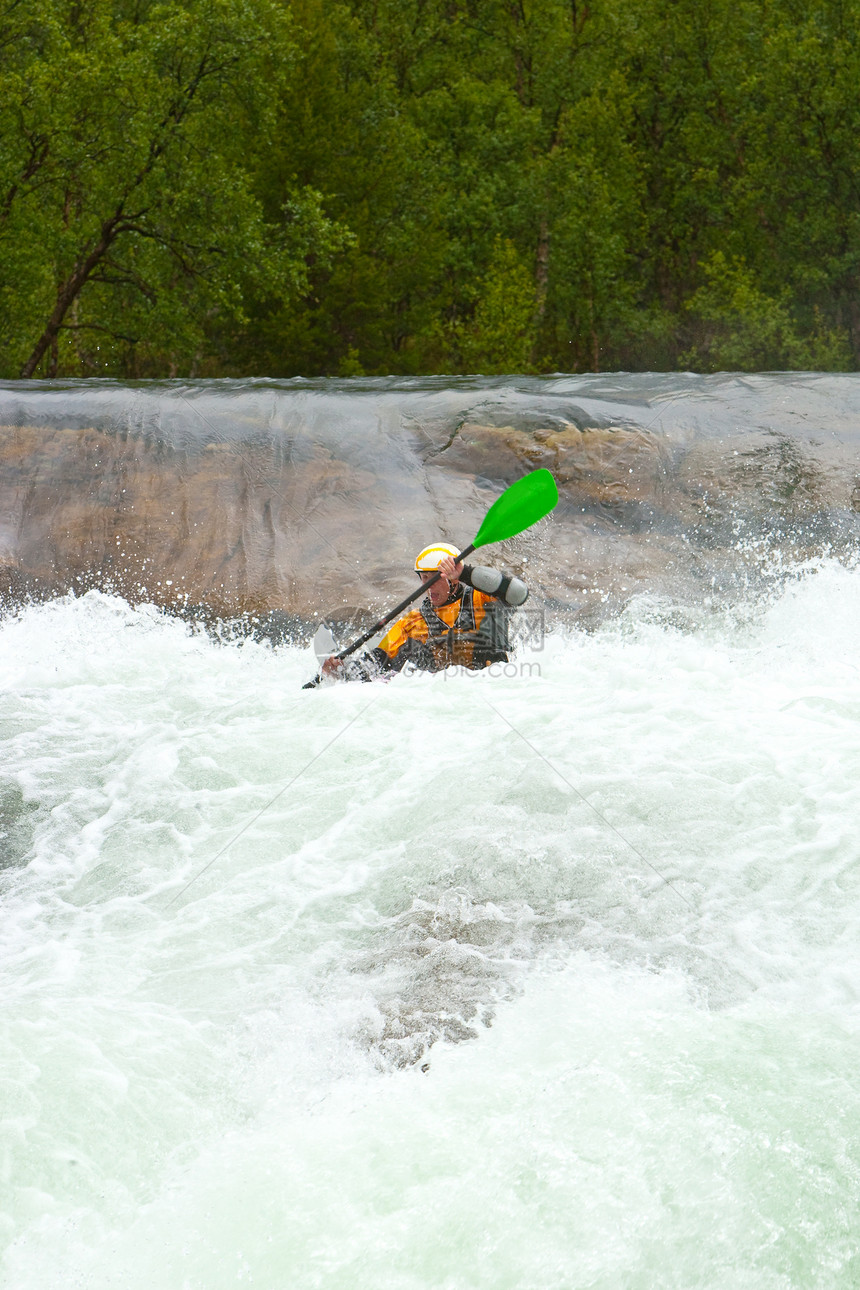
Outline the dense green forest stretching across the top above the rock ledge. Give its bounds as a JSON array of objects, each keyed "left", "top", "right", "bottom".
[{"left": 0, "top": 0, "right": 860, "bottom": 379}]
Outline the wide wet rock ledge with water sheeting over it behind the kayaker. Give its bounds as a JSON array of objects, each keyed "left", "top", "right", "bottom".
[{"left": 0, "top": 377, "right": 860, "bottom": 624}]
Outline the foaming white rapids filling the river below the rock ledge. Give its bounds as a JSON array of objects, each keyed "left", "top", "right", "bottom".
[{"left": 0, "top": 560, "right": 860, "bottom": 1290}]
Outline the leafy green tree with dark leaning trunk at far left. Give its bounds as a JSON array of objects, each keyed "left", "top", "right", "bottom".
[{"left": 0, "top": 0, "right": 338, "bottom": 377}]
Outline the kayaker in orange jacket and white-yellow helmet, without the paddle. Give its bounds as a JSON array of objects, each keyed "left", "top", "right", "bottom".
[{"left": 322, "top": 542, "right": 529, "bottom": 681}]
